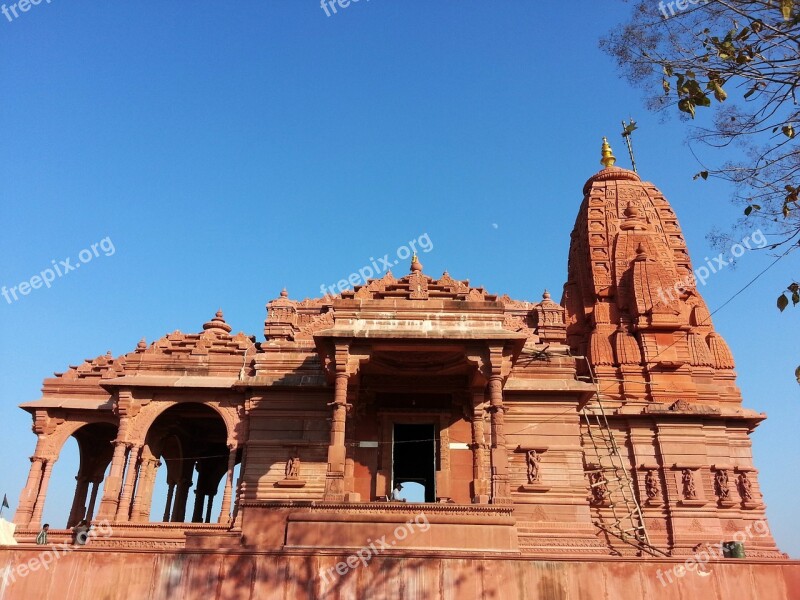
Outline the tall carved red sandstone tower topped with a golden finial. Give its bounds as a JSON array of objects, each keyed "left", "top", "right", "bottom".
[{"left": 562, "top": 139, "right": 778, "bottom": 557}]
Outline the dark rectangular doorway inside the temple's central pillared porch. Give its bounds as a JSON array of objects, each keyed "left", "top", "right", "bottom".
[{"left": 392, "top": 424, "right": 436, "bottom": 502}]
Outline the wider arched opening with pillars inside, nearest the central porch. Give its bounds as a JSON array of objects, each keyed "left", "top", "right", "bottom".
[{"left": 145, "top": 402, "right": 241, "bottom": 523}]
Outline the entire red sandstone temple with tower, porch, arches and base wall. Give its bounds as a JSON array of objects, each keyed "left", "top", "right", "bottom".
[{"left": 0, "top": 144, "right": 800, "bottom": 598}]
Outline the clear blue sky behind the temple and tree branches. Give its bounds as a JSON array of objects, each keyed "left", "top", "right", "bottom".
[{"left": 0, "top": 0, "right": 800, "bottom": 556}]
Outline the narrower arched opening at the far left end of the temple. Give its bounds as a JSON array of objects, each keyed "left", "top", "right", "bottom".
[{"left": 42, "top": 423, "right": 117, "bottom": 528}]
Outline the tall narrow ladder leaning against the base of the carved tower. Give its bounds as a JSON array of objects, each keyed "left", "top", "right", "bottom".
[{"left": 576, "top": 357, "right": 668, "bottom": 556}]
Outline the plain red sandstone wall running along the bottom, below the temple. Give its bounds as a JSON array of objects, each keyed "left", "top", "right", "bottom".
[{"left": 0, "top": 546, "right": 800, "bottom": 600}]
